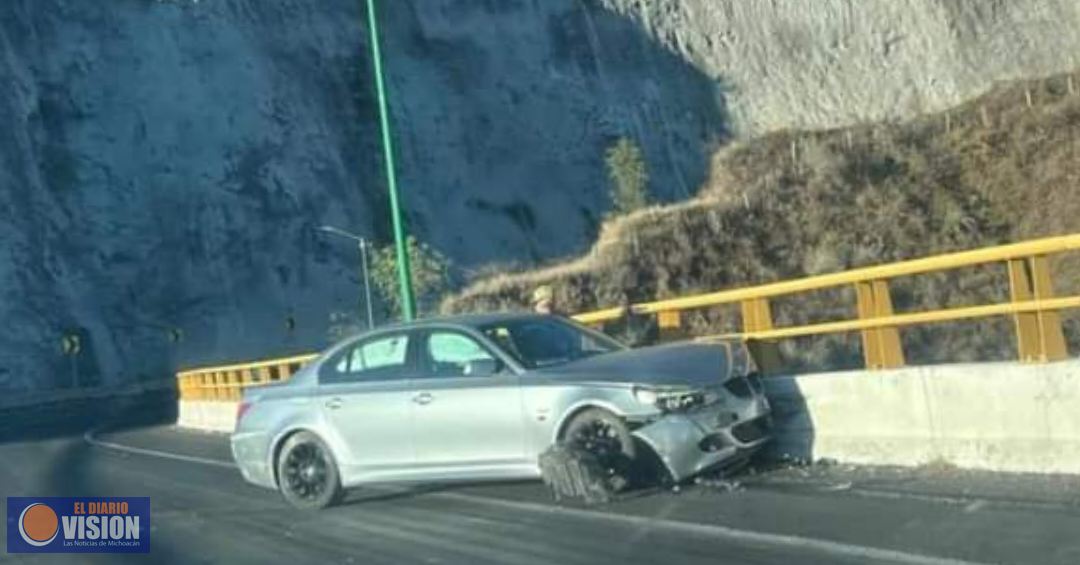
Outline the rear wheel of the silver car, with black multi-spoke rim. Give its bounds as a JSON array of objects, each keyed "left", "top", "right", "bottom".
[{"left": 276, "top": 431, "right": 342, "bottom": 510}]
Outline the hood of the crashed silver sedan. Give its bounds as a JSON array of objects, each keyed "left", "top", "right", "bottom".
[{"left": 535, "top": 344, "right": 731, "bottom": 386}]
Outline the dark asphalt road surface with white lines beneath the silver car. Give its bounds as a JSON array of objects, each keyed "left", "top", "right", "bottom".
[{"left": 0, "top": 426, "right": 1080, "bottom": 565}]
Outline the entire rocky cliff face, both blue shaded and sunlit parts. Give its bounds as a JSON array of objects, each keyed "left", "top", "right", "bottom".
[{"left": 0, "top": 0, "right": 1080, "bottom": 390}]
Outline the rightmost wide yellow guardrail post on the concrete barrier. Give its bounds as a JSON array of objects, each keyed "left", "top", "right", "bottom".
[{"left": 1009, "top": 255, "right": 1068, "bottom": 363}]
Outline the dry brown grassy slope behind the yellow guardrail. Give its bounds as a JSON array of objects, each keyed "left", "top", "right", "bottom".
[{"left": 444, "top": 76, "right": 1080, "bottom": 366}]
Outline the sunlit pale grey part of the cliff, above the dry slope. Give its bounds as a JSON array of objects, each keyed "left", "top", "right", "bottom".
[{"left": 608, "top": 0, "right": 1080, "bottom": 136}]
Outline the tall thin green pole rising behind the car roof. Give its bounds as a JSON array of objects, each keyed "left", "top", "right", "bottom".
[{"left": 367, "top": 0, "right": 416, "bottom": 322}]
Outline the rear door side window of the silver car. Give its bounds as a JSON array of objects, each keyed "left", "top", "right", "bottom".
[{"left": 320, "top": 334, "right": 409, "bottom": 382}]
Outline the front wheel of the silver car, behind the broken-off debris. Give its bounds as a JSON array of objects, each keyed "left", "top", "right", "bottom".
[{"left": 563, "top": 408, "right": 637, "bottom": 493}]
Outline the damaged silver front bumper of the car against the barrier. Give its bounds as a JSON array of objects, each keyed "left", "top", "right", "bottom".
[{"left": 633, "top": 393, "right": 772, "bottom": 481}]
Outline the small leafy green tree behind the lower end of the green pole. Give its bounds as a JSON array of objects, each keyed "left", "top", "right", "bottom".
[{"left": 372, "top": 236, "right": 450, "bottom": 315}]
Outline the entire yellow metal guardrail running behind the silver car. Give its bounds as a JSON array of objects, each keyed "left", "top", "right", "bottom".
[{"left": 177, "top": 233, "right": 1080, "bottom": 401}]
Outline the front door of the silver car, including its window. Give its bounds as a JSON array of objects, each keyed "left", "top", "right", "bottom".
[{"left": 413, "top": 328, "right": 526, "bottom": 474}]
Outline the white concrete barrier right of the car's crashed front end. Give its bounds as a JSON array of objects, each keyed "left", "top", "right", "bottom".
[{"left": 766, "top": 361, "right": 1080, "bottom": 473}]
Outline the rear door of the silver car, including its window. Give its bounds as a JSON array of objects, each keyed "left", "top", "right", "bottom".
[{"left": 319, "top": 332, "right": 416, "bottom": 480}]
